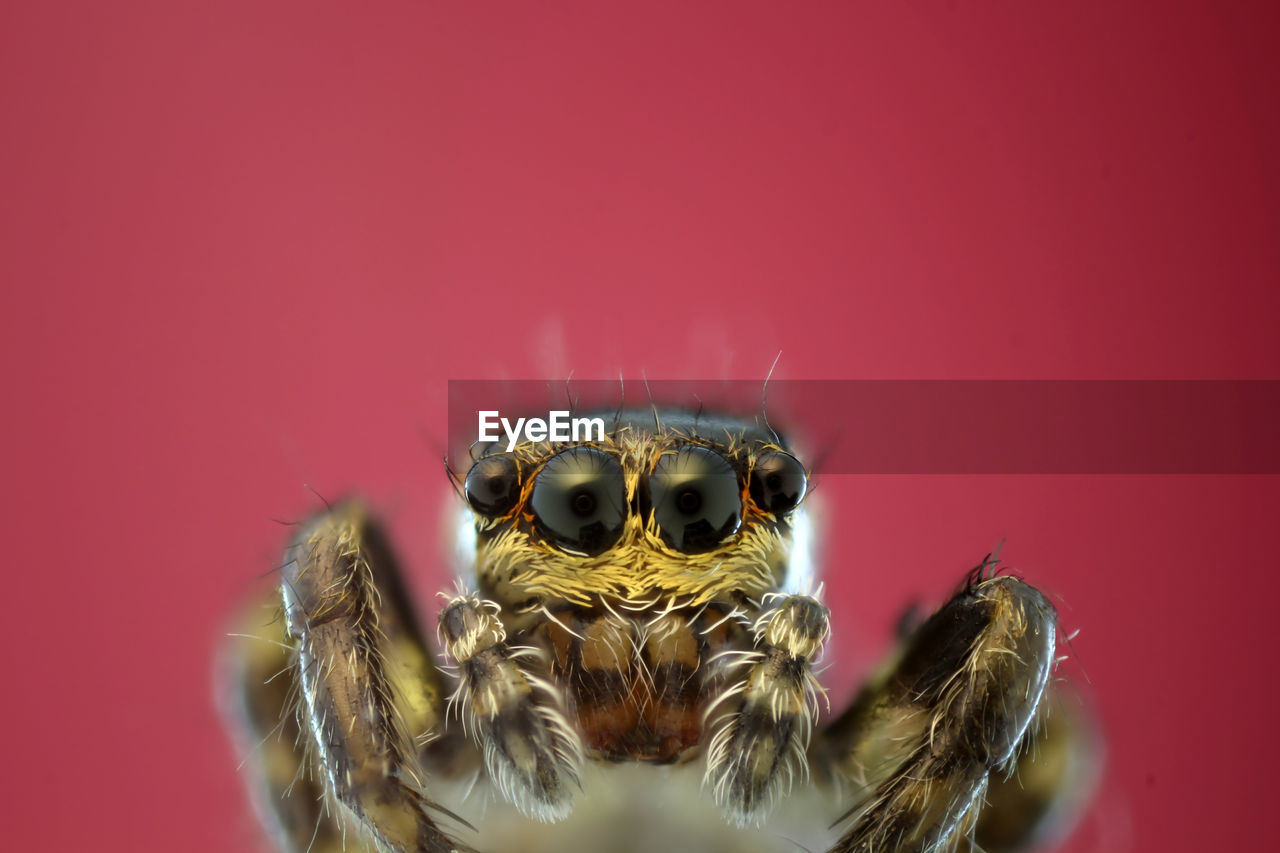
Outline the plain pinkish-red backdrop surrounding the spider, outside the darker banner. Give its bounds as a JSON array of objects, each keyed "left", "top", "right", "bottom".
[{"left": 0, "top": 1, "right": 1280, "bottom": 852}]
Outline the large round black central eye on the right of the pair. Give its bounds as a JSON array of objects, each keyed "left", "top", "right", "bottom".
[{"left": 649, "top": 447, "right": 742, "bottom": 553}]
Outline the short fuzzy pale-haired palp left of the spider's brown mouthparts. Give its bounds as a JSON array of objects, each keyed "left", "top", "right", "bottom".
[{"left": 440, "top": 596, "right": 582, "bottom": 822}]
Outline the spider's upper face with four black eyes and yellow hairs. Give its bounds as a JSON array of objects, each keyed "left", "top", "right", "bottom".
[{"left": 463, "top": 411, "right": 808, "bottom": 606}]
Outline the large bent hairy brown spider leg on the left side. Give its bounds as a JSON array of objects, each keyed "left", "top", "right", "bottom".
[{"left": 282, "top": 503, "right": 466, "bottom": 853}]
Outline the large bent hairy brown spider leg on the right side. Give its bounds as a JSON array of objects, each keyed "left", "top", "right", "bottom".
[{"left": 812, "top": 571, "right": 1056, "bottom": 853}]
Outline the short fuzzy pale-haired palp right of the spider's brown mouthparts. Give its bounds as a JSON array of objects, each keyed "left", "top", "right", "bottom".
[{"left": 705, "top": 596, "right": 831, "bottom": 826}]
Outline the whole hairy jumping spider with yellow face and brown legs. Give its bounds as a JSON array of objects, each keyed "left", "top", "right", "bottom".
[{"left": 227, "top": 410, "right": 1087, "bottom": 853}]
